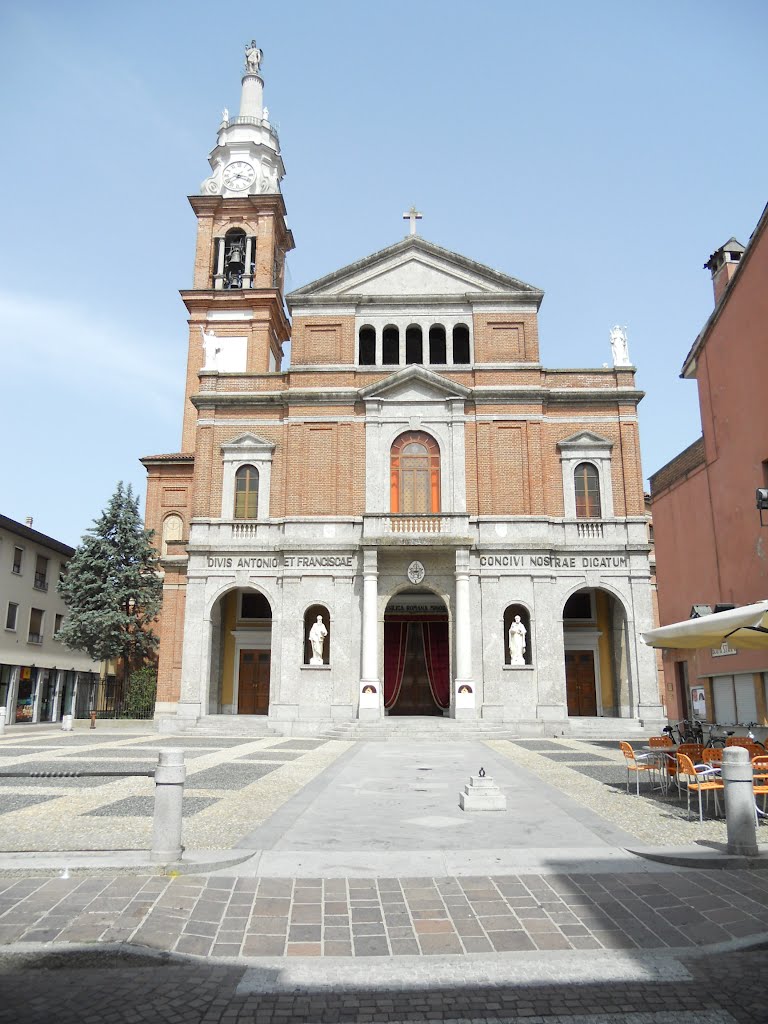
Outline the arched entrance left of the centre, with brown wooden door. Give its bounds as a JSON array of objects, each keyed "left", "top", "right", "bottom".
[{"left": 211, "top": 588, "right": 272, "bottom": 715}]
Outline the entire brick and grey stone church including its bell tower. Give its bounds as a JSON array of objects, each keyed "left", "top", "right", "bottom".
[{"left": 142, "top": 45, "right": 663, "bottom": 733}]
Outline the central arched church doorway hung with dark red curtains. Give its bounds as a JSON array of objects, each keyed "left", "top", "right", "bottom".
[{"left": 384, "top": 589, "right": 451, "bottom": 715}]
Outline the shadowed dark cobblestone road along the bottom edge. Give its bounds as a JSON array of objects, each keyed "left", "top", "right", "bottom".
[{"left": 0, "top": 951, "right": 766, "bottom": 1024}]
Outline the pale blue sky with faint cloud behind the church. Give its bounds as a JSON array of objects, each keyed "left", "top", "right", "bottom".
[{"left": 0, "top": 0, "right": 768, "bottom": 544}]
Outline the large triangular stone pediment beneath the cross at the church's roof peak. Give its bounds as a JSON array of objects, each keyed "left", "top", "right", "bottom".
[{"left": 287, "top": 234, "right": 543, "bottom": 307}]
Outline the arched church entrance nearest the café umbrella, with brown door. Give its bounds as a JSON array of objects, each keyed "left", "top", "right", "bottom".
[{"left": 562, "top": 588, "right": 630, "bottom": 718}]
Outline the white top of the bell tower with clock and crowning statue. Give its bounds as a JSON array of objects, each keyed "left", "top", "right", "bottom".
[{"left": 200, "top": 39, "right": 286, "bottom": 198}]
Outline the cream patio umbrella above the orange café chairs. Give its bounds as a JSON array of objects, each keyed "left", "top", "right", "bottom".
[{"left": 641, "top": 601, "right": 768, "bottom": 650}]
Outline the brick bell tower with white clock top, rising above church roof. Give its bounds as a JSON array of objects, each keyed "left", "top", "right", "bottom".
[{"left": 181, "top": 42, "right": 294, "bottom": 452}]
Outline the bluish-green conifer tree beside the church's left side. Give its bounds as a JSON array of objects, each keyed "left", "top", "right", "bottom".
[{"left": 57, "top": 481, "right": 163, "bottom": 685}]
